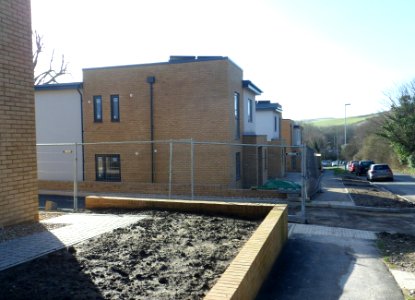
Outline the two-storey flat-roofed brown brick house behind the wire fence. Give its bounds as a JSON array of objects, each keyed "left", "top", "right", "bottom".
[{"left": 83, "top": 57, "right": 266, "bottom": 188}]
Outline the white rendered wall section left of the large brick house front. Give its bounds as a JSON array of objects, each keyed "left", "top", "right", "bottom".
[{"left": 35, "top": 89, "right": 83, "bottom": 181}]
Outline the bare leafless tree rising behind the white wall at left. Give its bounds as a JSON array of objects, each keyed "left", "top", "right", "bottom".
[{"left": 33, "top": 31, "right": 69, "bottom": 85}]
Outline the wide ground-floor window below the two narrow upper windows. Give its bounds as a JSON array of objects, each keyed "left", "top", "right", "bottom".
[{"left": 95, "top": 154, "right": 121, "bottom": 181}]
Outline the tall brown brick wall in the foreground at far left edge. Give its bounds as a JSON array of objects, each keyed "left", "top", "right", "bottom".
[{"left": 0, "top": 0, "right": 38, "bottom": 225}]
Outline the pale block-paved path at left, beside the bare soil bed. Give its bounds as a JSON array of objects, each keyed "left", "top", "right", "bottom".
[{"left": 0, "top": 213, "right": 147, "bottom": 271}]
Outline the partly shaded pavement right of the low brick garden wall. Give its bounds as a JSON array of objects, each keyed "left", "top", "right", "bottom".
[{"left": 257, "top": 224, "right": 403, "bottom": 300}]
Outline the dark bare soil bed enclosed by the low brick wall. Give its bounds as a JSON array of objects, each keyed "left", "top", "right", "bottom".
[{"left": 0, "top": 210, "right": 260, "bottom": 299}]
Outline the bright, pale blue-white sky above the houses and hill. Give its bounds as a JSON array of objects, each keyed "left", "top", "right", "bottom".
[{"left": 32, "top": 0, "right": 415, "bottom": 120}]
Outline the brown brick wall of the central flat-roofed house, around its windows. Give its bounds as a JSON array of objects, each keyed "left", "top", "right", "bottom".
[{"left": 83, "top": 59, "right": 243, "bottom": 187}]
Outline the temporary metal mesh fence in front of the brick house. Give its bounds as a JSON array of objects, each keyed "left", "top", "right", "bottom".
[{"left": 37, "top": 140, "right": 319, "bottom": 218}]
